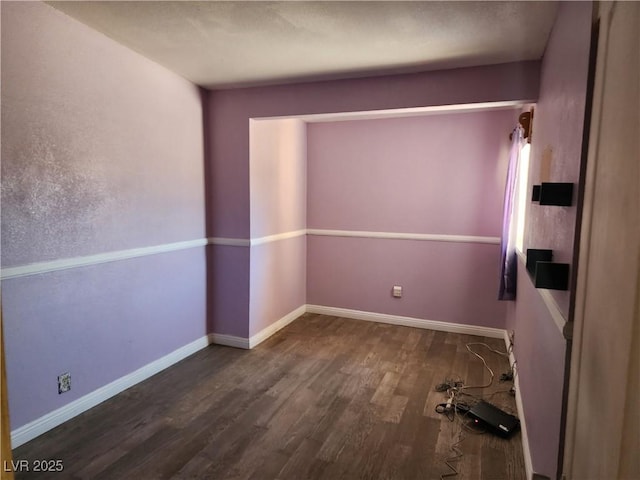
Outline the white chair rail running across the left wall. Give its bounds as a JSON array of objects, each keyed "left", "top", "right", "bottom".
[{"left": 0, "top": 238, "right": 209, "bottom": 280}]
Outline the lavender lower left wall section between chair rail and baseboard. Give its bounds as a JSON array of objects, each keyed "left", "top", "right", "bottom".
[{"left": 2, "top": 248, "right": 206, "bottom": 429}]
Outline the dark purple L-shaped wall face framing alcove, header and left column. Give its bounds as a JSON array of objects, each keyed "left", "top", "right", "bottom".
[{"left": 205, "top": 62, "right": 539, "bottom": 335}]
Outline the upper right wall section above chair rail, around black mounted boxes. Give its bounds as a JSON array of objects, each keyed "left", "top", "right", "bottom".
[{"left": 525, "top": 2, "right": 592, "bottom": 317}]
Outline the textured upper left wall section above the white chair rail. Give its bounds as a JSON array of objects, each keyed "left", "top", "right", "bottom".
[{"left": 2, "top": 2, "right": 204, "bottom": 267}]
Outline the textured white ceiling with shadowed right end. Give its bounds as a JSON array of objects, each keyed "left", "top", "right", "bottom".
[{"left": 47, "top": 1, "right": 557, "bottom": 88}]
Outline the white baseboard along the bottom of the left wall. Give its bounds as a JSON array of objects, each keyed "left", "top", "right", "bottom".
[{"left": 11, "top": 336, "right": 209, "bottom": 448}]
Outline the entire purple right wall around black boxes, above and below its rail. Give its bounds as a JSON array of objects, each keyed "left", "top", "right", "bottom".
[{"left": 507, "top": 2, "right": 591, "bottom": 478}]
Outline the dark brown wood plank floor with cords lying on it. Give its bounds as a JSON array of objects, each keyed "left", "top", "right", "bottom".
[{"left": 14, "top": 314, "right": 525, "bottom": 480}]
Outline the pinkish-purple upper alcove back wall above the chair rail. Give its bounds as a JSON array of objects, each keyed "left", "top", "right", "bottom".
[{"left": 307, "top": 109, "right": 519, "bottom": 237}]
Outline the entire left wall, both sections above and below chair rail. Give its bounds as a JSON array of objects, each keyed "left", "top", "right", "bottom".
[{"left": 1, "top": 2, "right": 206, "bottom": 429}]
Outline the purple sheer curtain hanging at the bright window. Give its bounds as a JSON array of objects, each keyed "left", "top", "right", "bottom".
[{"left": 498, "top": 125, "right": 525, "bottom": 300}]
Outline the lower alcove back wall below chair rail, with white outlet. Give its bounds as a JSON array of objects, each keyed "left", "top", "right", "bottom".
[{"left": 307, "top": 235, "right": 506, "bottom": 328}]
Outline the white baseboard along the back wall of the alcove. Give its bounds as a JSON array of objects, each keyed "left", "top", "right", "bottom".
[{"left": 307, "top": 305, "right": 504, "bottom": 338}]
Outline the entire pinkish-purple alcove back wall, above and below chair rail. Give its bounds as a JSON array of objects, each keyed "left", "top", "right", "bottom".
[{"left": 307, "top": 109, "right": 519, "bottom": 328}]
